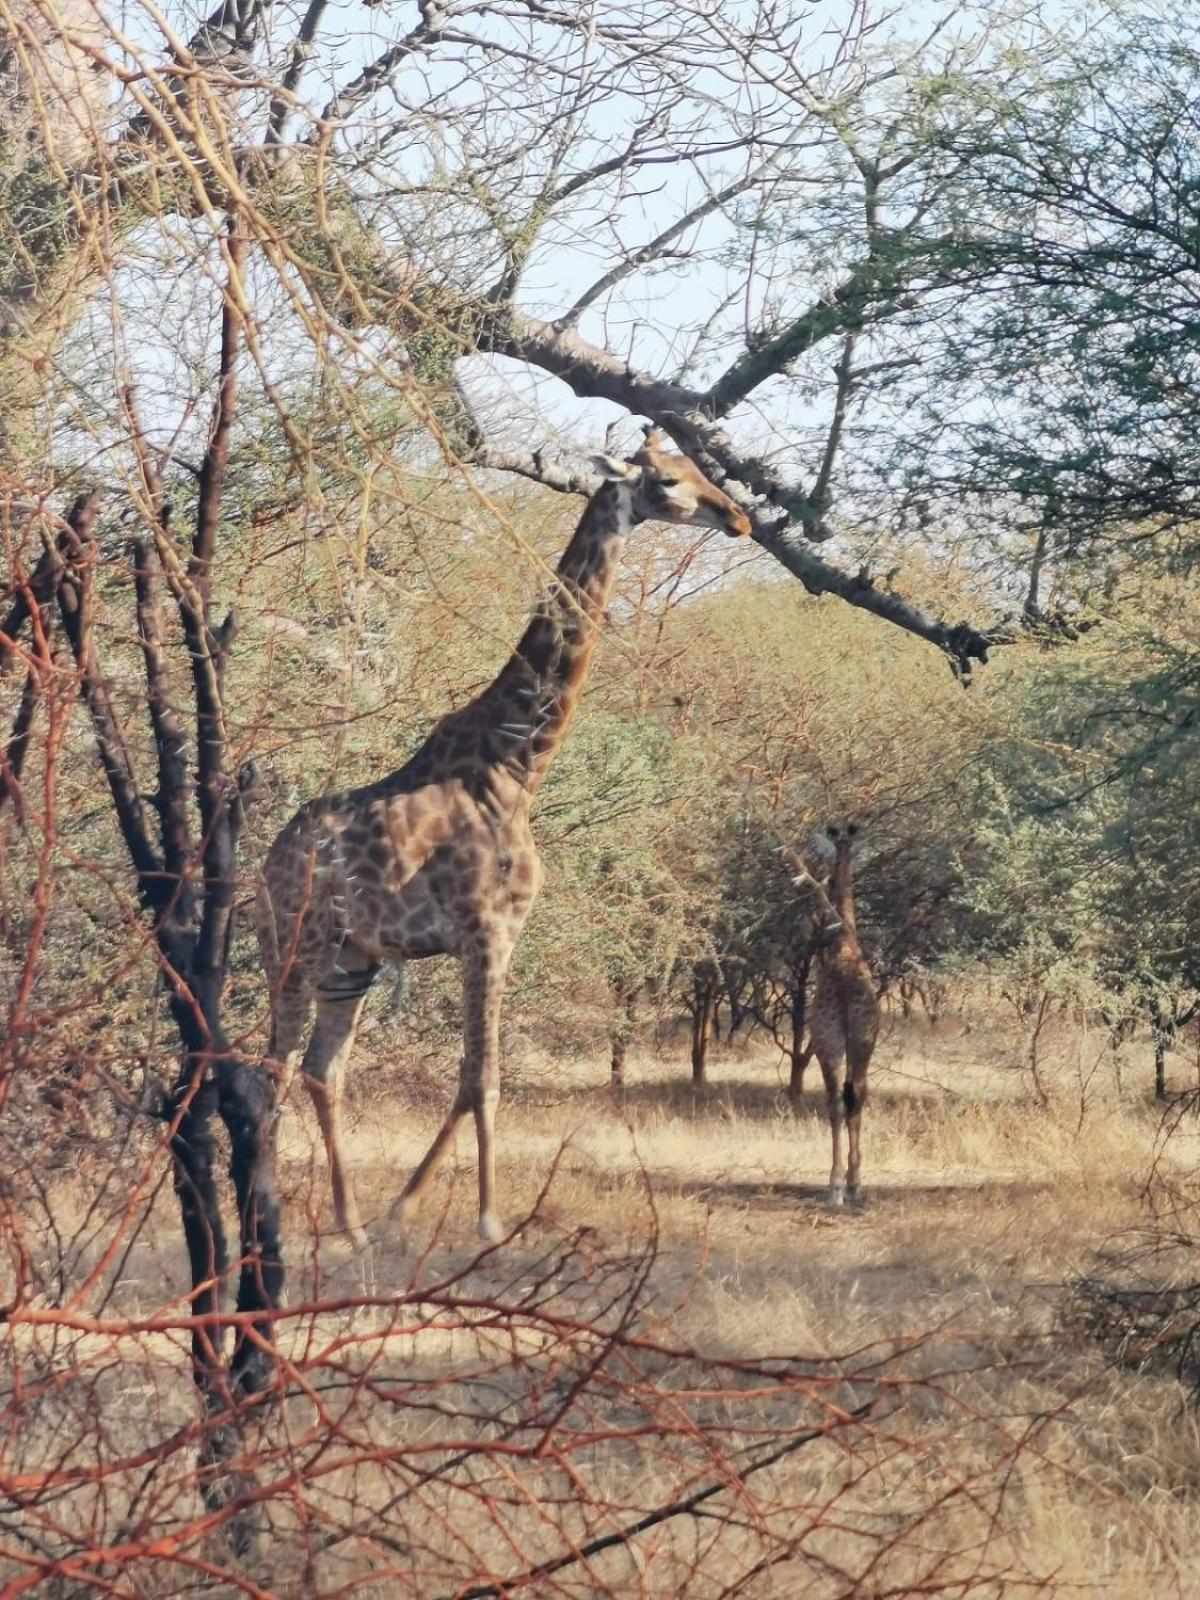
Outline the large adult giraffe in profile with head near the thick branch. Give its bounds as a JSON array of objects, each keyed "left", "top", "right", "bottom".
[{"left": 254, "top": 430, "right": 750, "bottom": 1248}]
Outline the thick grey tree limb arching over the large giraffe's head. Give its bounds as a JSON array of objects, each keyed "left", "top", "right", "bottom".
[{"left": 0, "top": 0, "right": 998, "bottom": 672}]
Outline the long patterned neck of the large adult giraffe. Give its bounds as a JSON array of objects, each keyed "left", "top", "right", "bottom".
[{"left": 475, "top": 483, "right": 632, "bottom": 790}]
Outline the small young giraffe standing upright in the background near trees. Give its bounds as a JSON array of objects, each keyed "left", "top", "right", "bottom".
[{"left": 802, "top": 822, "right": 880, "bottom": 1206}]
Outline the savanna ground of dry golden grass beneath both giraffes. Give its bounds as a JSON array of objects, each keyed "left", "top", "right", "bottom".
[{"left": 5, "top": 1018, "right": 1200, "bottom": 1600}]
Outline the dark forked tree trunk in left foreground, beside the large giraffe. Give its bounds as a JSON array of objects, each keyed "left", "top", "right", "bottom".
[{"left": 37, "top": 347, "right": 283, "bottom": 1547}]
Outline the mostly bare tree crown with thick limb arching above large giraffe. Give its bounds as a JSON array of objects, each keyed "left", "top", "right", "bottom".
[{"left": 0, "top": 0, "right": 1056, "bottom": 670}]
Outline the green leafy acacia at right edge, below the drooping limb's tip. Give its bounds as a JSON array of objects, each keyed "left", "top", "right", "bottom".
[{"left": 947, "top": 576, "right": 1200, "bottom": 1098}]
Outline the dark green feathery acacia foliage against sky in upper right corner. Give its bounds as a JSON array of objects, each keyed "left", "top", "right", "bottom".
[{"left": 907, "top": 0, "right": 1200, "bottom": 556}]
